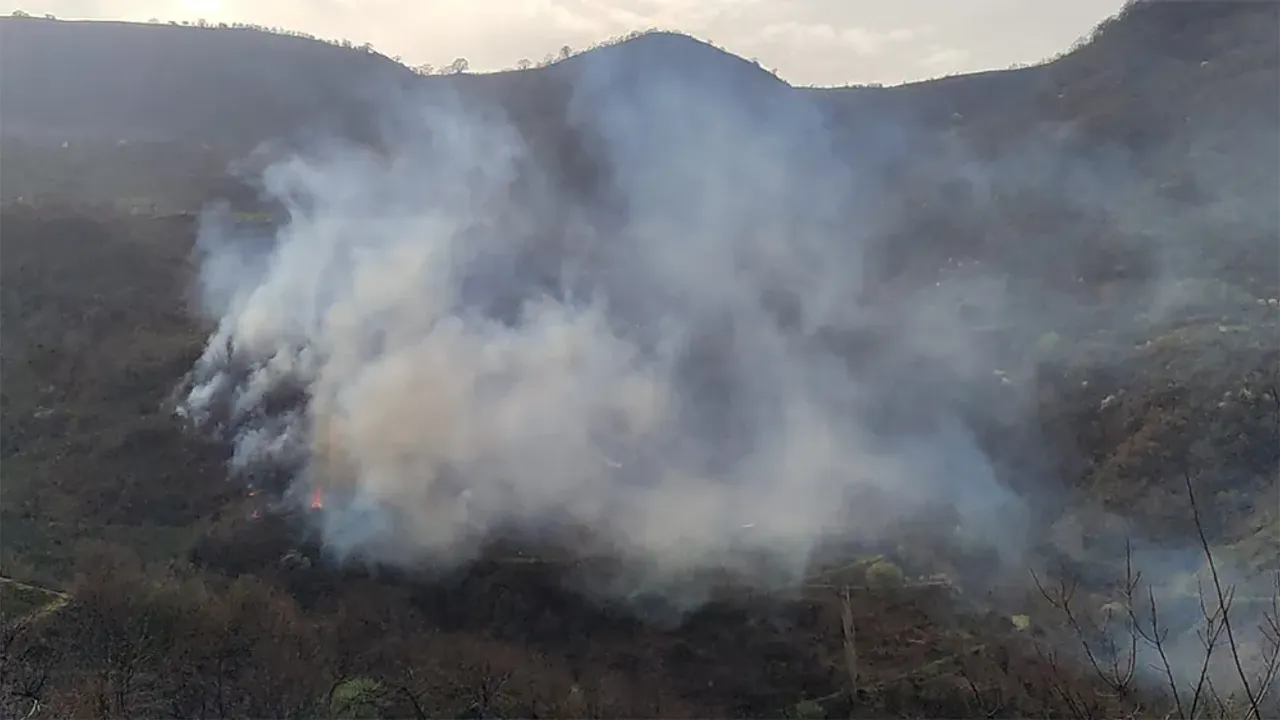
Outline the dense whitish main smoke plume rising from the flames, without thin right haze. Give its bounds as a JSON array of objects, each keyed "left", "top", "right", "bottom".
[{"left": 183, "top": 56, "right": 1023, "bottom": 597}]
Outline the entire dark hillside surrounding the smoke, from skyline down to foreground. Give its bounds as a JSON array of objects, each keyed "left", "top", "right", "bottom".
[{"left": 0, "top": 3, "right": 1280, "bottom": 717}]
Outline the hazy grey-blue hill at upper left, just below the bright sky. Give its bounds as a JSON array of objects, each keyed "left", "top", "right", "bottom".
[{"left": 0, "top": 18, "right": 416, "bottom": 147}]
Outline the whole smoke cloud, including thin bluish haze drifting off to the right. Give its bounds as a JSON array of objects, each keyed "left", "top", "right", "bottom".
[{"left": 180, "top": 28, "right": 1271, "bottom": 645}]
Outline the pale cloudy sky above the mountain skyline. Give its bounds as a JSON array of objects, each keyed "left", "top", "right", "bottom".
[{"left": 0, "top": 0, "right": 1123, "bottom": 86}]
